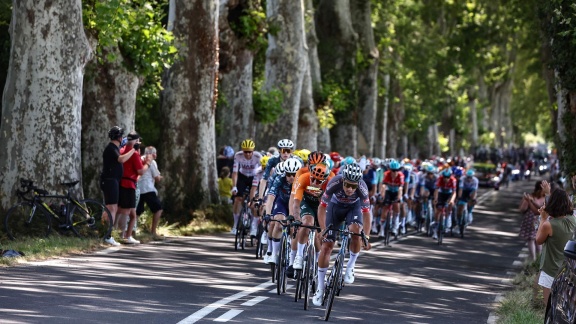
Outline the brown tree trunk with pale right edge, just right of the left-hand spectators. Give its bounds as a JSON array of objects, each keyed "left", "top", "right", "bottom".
[{"left": 160, "top": 0, "right": 218, "bottom": 214}]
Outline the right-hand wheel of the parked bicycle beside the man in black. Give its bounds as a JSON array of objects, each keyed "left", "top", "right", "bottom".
[{"left": 70, "top": 199, "right": 114, "bottom": 239}]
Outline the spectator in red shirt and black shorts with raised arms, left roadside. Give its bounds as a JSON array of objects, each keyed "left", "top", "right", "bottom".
[{"left": 117, "top": 131, "right": 152, "bottom": 244}]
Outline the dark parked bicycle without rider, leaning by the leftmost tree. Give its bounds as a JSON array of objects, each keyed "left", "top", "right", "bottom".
[{"left": 4, "top": 179, "right": 113, "bottom": 240}]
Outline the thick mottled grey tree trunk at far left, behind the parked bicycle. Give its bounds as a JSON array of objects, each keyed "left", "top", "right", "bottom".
[{"left": 0, "top": 0, "right": 92, "bottom": 209}]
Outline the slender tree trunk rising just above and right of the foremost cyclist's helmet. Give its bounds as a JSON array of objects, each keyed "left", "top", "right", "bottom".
[{"left": 350, "top": 0, "right": 380, "bottom": 156}]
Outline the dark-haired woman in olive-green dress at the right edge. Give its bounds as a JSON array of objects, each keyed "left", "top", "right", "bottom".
[{"left": 536, "top": 188, "right": 576, "bottom": 306}]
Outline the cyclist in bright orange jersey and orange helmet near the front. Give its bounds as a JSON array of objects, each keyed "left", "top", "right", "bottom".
[{"left": 292, "top": 163, "right": 334, "bottom": 270}]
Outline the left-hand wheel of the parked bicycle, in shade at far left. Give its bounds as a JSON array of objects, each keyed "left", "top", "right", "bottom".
[{"left": 4, "top": 201, "right": 50, "bottom": 240}]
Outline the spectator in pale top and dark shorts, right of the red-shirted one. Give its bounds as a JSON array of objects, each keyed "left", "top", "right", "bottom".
[{"left": 136, "top": 146, "right": 163, "bottom": 239}]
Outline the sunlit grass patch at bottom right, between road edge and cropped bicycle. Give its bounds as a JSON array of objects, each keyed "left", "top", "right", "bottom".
[{"left": 496, "top": 260, "right": 545, "bottom": 324}]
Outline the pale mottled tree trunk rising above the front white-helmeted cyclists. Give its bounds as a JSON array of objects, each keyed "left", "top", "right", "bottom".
[{"left": 256, "top": 0, "right": 307, "bottom": 147}]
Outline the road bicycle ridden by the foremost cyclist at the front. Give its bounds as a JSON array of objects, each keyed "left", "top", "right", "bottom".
[{"left": 321, "top": 224, "right": 368, "bottom": 321}]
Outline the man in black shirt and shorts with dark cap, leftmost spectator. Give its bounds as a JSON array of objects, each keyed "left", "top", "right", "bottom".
[{"left": 100, "top": 126, "right": 135, "bottom": 246}]
